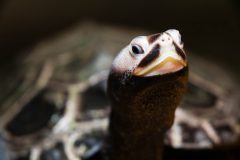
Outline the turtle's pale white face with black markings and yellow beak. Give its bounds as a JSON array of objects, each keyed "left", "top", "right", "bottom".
[{"left": 112, "top": 29, "right": 187, "bottom": 77}]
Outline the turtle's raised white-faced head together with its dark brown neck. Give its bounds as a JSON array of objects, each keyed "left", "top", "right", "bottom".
[{"left": 104, "top": 30, "right": 188, "bottom": 160}]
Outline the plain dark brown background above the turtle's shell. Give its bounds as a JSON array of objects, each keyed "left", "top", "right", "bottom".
[{"left": 0, "top": 0, "right": 240, "bottom": 77}]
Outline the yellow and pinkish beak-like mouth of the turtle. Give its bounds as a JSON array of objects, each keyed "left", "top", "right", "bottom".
[{"left": 133, "top": 57, "right": 187, "bottom": 77}]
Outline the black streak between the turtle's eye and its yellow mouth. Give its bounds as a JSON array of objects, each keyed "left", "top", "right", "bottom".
[{"left": 138, "top": 44, "right": 160, "bottom": 67}]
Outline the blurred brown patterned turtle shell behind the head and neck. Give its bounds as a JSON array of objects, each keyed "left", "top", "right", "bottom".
[{"left": 0, "top": 23, "right": 239, "bottom": 159}]
